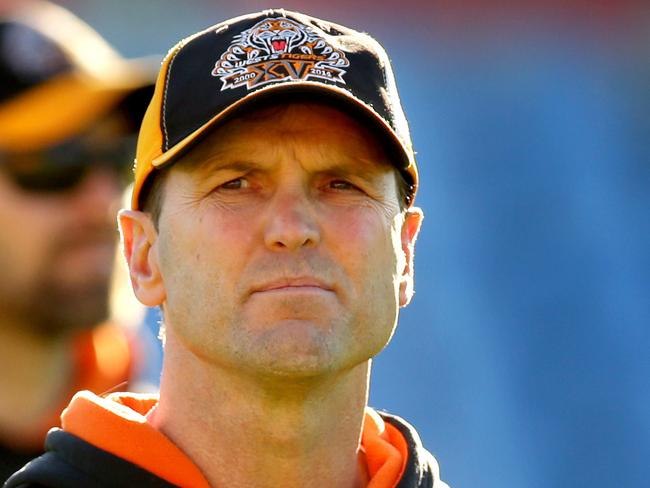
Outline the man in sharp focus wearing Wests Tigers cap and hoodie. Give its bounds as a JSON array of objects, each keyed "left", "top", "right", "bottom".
[{"left": 7, "top": 10, "right": 447, "bottom": 488}]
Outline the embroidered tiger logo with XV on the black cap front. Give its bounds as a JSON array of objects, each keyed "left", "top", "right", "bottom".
[{"left": 212, "top": 17, "right": 350, "bottom": 91}]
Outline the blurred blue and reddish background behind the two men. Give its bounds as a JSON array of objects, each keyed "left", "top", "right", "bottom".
[{"left": 10, "top": 0, "right": 650, "bottom": 488}]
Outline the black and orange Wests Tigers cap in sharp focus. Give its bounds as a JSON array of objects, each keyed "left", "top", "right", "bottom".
[{"left": 131, "top": 9, "right": 418, "bottom": 209}]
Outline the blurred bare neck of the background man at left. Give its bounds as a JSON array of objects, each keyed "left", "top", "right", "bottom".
[{"left": 0, "top": 321, "right": 70, "bottom": 449}]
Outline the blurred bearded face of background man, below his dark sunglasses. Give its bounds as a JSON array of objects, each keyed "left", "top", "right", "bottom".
[{"left": 0, "top": 117, "right": 128, "bottom": 335}]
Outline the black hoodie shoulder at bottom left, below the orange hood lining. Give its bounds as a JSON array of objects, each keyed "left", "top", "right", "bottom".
[{"left": 4, "top": 429, "right": 174, "bottom": 488}]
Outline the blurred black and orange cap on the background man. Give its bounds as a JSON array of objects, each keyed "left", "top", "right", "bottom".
[{"left": 0, "top": 0, "right": 158, "bottom": 152}]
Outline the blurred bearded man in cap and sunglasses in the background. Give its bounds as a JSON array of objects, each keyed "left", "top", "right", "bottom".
[{"left": 0, "top": 2, "right": 153, "bottom": 482}]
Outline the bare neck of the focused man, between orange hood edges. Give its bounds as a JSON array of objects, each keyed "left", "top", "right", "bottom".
[{"left": 149, "top": 331, "right": 370, "bottom": 488}]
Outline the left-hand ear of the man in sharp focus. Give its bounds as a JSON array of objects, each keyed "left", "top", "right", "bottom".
[{"left": 118, "top": 209, "right": 166, "bottom": 307}]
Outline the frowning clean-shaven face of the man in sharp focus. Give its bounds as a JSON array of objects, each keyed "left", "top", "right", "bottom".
[{"left": 144, "top": 104, "right": 420, "bottom": 376}]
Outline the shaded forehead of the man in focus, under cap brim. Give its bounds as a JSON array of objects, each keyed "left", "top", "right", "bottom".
[{"left": 175, "top": 102, "right": 392, "bottom": 172}]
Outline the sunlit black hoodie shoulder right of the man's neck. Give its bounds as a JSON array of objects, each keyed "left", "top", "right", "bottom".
[{"left": 377, "top": 410, "right": 449, "bottom": 488}]
